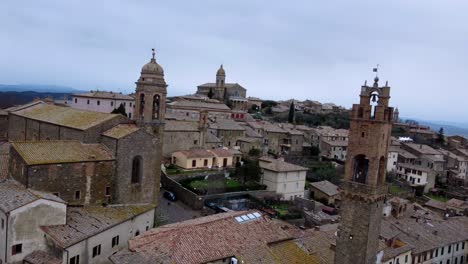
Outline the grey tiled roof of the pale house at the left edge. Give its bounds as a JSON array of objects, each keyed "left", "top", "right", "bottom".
[{"left": 0, "top": 179, "right": 65, "bottom": 213}]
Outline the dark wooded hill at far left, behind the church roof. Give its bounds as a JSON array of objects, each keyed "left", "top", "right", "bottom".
[{"left": 0, "top": 91, "right": 71, "bottom": 109}]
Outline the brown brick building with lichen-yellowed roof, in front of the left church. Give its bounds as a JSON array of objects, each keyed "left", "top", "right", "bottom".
[{"left": 9, "top": 140, "right": 115, "bottom": 205}]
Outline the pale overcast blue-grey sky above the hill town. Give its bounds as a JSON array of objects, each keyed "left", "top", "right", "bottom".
[{"left": 0, "top": 0, "right": 468, "bottom": 121}]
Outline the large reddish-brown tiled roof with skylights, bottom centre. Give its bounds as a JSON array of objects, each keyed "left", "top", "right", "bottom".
[{"left": 110, "top": 211, "right": 309, "bottom": 264}]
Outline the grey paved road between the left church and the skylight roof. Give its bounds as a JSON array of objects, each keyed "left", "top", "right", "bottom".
[{"left": 157, "top": 189, "right": 201, "bottom": 224}]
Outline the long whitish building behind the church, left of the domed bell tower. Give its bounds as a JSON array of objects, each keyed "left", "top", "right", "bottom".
[{"left": 67, "top": 91, "right": 135, "bottom": 119}]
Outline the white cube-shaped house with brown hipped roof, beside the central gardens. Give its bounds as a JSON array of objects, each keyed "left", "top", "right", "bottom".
[{"left": 259, "top": 157, "right": 308, "bottom": 200}]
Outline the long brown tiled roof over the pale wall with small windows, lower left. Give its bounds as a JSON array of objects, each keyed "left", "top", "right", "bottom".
[{"left": 41, "top": 204, "right": 154, "bottom": 248}]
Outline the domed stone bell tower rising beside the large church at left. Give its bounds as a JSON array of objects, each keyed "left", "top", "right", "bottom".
[{"left": 134, "top": 49, "right": 167, "bottom": 204}]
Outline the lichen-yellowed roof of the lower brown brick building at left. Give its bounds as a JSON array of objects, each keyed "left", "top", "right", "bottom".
[{"left": 11, "top": 140, "right": 114, "bottom": 165}]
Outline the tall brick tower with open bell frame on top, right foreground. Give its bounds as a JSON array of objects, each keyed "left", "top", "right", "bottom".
[{"left": 335, "top": 74, "right": 393, "bottom": 264}]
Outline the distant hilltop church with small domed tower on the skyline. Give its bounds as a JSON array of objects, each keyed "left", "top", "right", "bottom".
[{"left": 197, "top": 65, "right": 248, "bottom": 111}]
